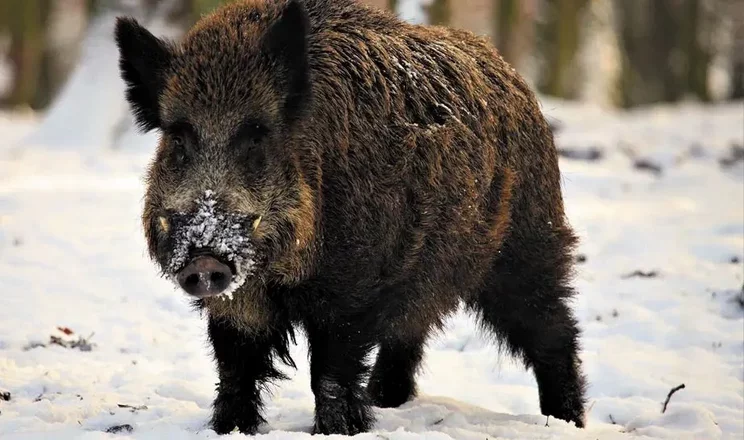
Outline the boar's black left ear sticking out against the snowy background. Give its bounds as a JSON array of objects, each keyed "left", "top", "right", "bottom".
[{"left": 115, "top": 17, "right": 173, "bottom": 132}]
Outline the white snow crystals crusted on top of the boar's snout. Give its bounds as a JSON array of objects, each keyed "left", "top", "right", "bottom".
[{"left": 167, "top": 190, "right": 255, "bottom": 299}]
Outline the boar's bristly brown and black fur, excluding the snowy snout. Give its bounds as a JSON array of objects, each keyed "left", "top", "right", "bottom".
[{"left": 117, "top": 0, "right": 585, "bottom": 434}]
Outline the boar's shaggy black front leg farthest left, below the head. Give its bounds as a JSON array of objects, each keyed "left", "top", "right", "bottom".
[{"left": 208, "top": 318, "right": 293, "bottom": 434}]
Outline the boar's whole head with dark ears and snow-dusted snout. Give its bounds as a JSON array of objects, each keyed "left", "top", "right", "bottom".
[{"left": 115, "top": 0, "right": 317, "bottom": 298}]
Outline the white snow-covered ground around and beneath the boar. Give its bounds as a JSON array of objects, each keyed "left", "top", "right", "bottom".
[{"left": 0, "top": 100, "right": 744, "bottom": 440}]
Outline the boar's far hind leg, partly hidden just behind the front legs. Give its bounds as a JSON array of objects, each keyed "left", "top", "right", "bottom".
[{"left": 367, "top": 334, "right": 426, "bottom": 408}]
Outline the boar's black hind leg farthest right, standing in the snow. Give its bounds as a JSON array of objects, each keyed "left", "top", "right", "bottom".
[{"left": 471, "top": 237, "right": 585, "bottom": 427}]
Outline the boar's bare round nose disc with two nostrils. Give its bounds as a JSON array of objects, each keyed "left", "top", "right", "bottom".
[{"left": 176, "top": 255, "right": 233, "bottom": 297}]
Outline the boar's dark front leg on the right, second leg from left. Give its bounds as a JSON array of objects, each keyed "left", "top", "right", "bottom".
[{"left": 306, "top": 322, "right": 374, "bottom": 435}]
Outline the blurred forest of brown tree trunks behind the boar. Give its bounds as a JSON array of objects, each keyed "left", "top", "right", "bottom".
[{"left": 0, "top": 0, "right": 744, "bottom": 110}]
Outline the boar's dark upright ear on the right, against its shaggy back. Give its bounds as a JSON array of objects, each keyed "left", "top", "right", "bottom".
[{"left": 263, "top": 0, "right": 310, "bottom": 119}]
